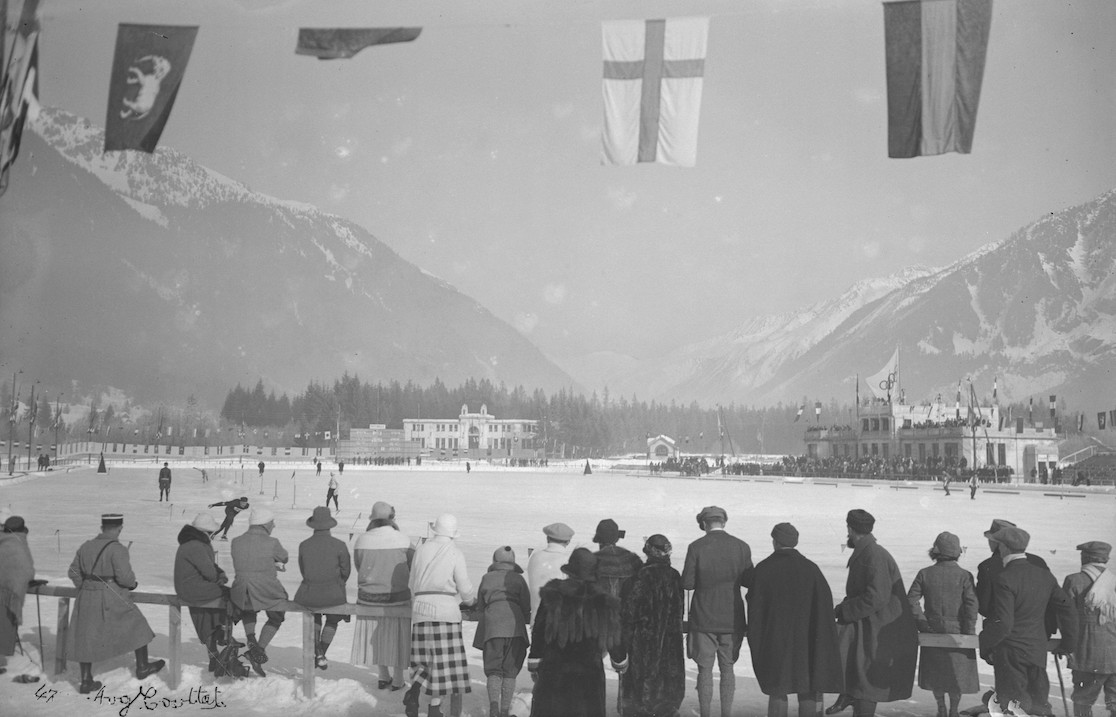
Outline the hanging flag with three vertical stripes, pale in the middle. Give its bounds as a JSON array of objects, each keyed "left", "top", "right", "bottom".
[{"left": 884, "top": 0, "right": 992, "bottom": 159}]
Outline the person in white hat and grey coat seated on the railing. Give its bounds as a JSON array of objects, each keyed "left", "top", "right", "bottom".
[{"left": 231, "top": 508, "right": 289, "bottom": 677}]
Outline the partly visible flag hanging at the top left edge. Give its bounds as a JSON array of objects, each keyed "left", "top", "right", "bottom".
[{"left": 0, "top": 0, "right": 39, "bottom": 194}]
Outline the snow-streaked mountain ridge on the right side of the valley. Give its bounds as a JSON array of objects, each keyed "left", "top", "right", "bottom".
[{"left": 567, "top": 190, "right": 1116, "bottom": 405}]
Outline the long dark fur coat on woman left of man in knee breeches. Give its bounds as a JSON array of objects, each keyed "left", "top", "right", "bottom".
[{"left": 620, "top": 557, "right": 686, "bottom": 717}]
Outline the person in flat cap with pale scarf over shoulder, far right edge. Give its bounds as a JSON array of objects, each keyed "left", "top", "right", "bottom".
[{"left": 1062, "top": 541, "right": 1116, "bottom": 717}]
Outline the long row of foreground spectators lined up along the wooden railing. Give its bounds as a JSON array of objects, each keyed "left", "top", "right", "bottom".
[{"left": 0, "top": 491, "right": 1116, "bottom": 717}]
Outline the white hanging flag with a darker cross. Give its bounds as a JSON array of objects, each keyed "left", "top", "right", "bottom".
[{"left": 602, "top": 18, "right": 709, "bottom": 166}]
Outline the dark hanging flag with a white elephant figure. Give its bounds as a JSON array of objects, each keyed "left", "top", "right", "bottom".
[{"left": 105, "top": 22, "right": 198, "bottom": 153}]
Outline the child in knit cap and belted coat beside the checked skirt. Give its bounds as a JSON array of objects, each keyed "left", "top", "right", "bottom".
[{"left": 473, "top": 545, "right": 531, "bottom": 717}]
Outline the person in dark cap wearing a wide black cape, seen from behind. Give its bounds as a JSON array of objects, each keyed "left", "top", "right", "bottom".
[{"left": 744, "top": 523, "right": 845, "bottom": 717}]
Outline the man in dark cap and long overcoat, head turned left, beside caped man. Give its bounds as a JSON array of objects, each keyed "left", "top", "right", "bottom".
[{"left": 826, "top": 508, "right": 918, "bottom": 717}]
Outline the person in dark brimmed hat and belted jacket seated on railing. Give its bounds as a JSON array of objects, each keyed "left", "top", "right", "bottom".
[{"left": 295, "top": 506, "right": 353, "bottom": 670}]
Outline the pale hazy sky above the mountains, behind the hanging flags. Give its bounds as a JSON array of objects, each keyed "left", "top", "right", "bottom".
[{"left": 32, "top": 0, "right": 1116, "bottom": 360}]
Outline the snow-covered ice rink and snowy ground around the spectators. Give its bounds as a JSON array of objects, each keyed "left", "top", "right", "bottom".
[{"left": 0, "top": 463, "right": 1116, "bottom": 717}]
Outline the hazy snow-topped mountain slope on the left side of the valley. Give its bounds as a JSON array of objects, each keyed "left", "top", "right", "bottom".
[{"left": 0, "top": 109, "right": 574, "bottom": 405}]
